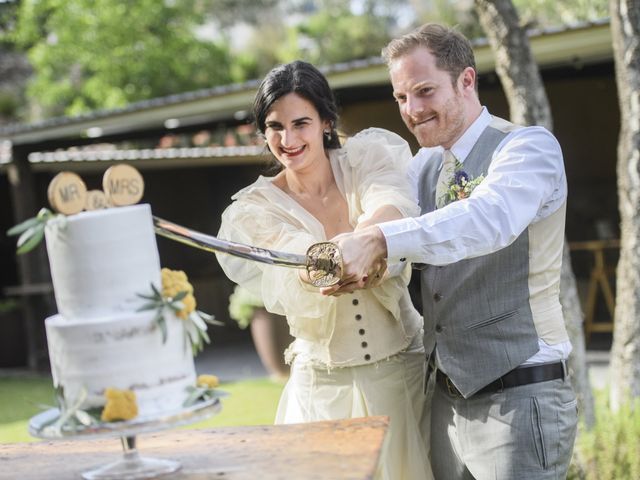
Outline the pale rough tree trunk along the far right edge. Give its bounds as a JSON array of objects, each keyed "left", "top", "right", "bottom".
[{"left": 609, "top": 0, "right": 640, "bottom": 410}]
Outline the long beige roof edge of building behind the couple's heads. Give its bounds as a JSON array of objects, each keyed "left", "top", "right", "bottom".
[{"left": 0, "top": 19, "right": 613, "bottom": 146}]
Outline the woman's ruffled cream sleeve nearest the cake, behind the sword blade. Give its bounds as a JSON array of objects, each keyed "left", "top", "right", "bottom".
[{"left": 216, "top": 179, "right": 335, "bottom": 343}]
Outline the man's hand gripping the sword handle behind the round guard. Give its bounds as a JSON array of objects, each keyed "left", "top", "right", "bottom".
[{"left": 320, "top": 225, "right": 387, "bottom": 295}]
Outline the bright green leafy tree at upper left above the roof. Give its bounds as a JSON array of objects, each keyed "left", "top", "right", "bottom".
[{"left": 14, "top": 0, "right": 231, "bottom": 119}]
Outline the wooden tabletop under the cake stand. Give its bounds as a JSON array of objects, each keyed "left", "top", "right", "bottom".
[{"left": 0, "top": 417, "right": 389, "bottom": 480}]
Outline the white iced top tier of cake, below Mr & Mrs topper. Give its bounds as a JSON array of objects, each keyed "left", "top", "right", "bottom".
[{"left": 45, "top": 205, "right": 160, "bottom": 321}]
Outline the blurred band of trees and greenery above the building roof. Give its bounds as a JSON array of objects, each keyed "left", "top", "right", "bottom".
[{"left": 0, "top": 0, "right": 608, "bottom": 123}]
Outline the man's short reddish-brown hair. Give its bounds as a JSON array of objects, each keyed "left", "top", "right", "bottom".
[{"left": 382, "top": 23, "right": 476, "bottom": 90}]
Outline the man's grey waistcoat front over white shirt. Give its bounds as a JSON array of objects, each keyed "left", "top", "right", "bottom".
[{"left": 419, "top": 119, "right": 564, "bottom": 397}]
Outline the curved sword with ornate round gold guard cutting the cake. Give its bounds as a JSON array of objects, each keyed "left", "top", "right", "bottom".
[{"left": 153, "top": 216, "right": 342, "bottom": 287}]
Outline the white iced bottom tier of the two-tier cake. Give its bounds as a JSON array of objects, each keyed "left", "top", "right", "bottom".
[{"left": 45, "top": 311, "right": 195, "bottom": 417}]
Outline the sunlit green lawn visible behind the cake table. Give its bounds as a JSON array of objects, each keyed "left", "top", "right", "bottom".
[{"left": 0, "top": 376, "right": 283, "bottom": 443}]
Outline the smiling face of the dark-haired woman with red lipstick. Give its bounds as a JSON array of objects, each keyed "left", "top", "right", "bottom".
[{"left": 264, "top": 93, "right": 329, "bottom": 171}]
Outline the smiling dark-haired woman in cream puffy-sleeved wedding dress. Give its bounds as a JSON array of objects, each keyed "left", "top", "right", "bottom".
[{"left": 218, "top": 61, "right": 432, "bottom": 480}]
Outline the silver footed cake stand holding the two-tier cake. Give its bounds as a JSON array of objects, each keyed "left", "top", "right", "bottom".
[{"left": 29, "top": 398, "right": 222, "bottom": 480}]
